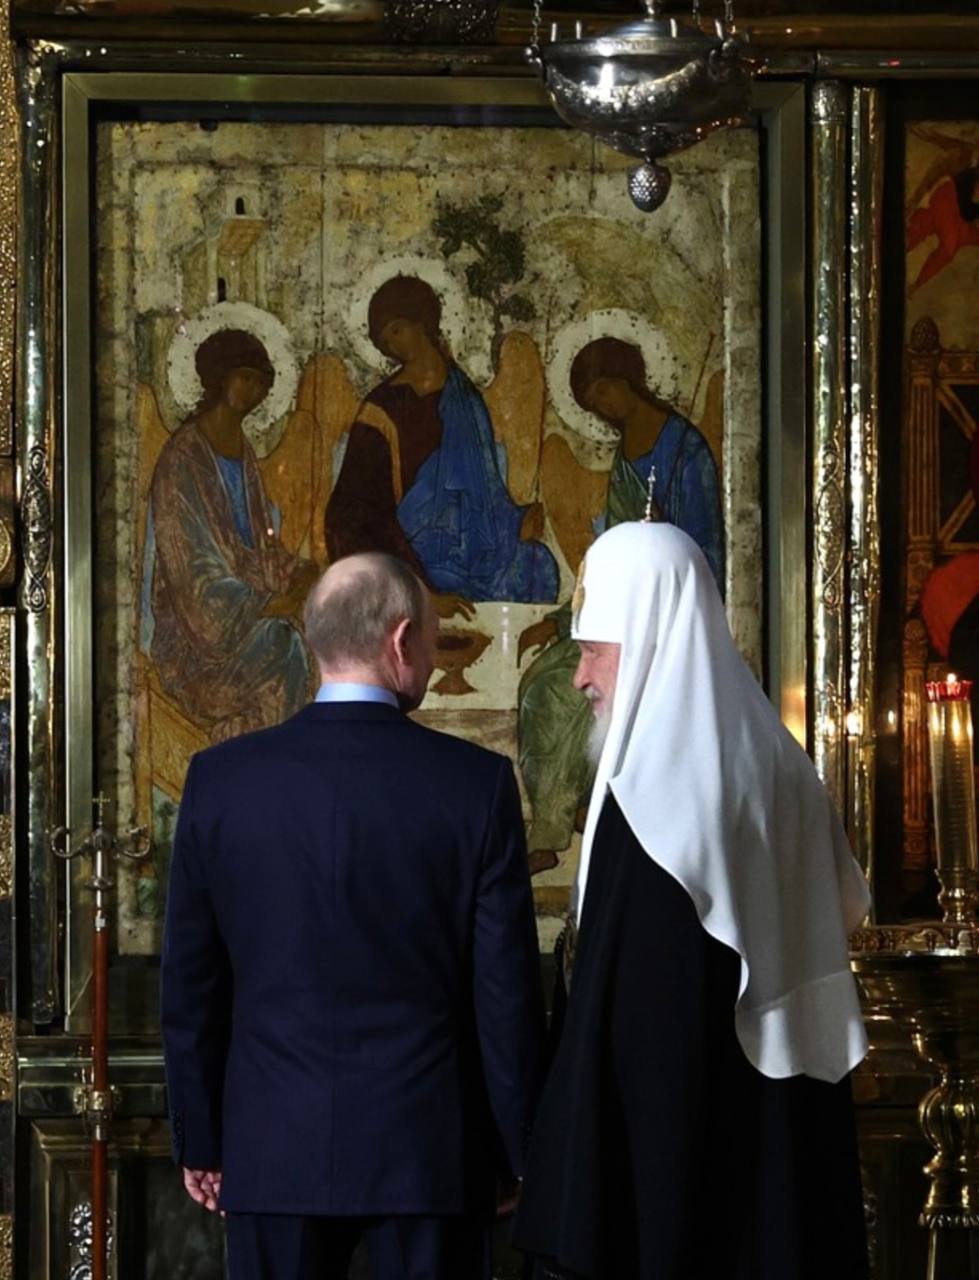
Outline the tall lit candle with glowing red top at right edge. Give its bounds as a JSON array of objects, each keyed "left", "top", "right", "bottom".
[{"left": 925, "top": 672, "right": 979, "bottom": 924}]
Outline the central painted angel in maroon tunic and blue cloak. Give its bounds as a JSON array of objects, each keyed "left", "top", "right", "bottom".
[{"left": 325, "top": 276, "right": 558, "bottom": 616}]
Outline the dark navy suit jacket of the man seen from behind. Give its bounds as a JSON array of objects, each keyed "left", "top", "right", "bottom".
[{"left": 163, "top": 703, "right": 543, "bottom": 1280}]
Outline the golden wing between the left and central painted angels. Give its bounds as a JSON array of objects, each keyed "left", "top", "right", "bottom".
[{"left": 260, "top": 356, "right": 358, "bottom": 564}]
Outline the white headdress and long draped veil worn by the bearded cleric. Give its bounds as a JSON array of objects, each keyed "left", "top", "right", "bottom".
[{"left": 572, "top": 524, "right": 870, "bottom": 1080}]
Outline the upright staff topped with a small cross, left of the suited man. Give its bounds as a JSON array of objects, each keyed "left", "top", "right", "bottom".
[{"left": 51, "top": 791, "right": 151, "bottom": 1280}]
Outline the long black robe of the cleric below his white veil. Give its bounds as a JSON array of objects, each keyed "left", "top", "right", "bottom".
[{"left": 514, "top": 796, "right": 868, "bottom": 1280}]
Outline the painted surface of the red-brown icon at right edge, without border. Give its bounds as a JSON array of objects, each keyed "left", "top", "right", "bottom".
[{"left": 902, "top": 120, "right": 979, "bottom": 877}]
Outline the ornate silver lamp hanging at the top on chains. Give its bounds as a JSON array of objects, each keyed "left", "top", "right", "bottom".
[{"left": 527, "top": 0, "right": 752, "bottom": 212}]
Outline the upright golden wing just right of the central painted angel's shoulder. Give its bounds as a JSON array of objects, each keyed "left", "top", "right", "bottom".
[{"left": 484, "top": 329, "right": 546, "bottom": 504}]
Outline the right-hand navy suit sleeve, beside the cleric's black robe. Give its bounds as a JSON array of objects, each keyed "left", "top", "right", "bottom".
[{"left": 474, "top": 762, "right": 544, "bottom": 1176}]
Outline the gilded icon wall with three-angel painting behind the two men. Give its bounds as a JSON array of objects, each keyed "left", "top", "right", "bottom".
[{"left": 0, "top": 0, "right": 979, "bottom": 1280}]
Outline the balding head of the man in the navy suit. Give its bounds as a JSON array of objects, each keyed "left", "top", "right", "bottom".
[{"left": 305, "top": 552, "right": 431, "bottom": 671}]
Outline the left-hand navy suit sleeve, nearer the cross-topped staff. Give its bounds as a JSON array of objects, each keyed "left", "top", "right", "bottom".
[{"left": 160, "top": 760, "right": 232, "bottom": 1170}]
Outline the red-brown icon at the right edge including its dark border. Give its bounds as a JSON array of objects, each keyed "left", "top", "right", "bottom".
[{"left": 877, "top": 107, "right": 979, "bottom": 920}]
